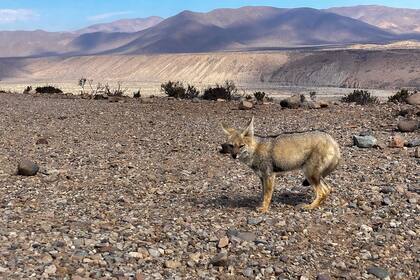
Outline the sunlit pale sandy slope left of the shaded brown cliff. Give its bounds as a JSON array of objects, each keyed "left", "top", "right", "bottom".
[{"left": 0, "top": 52, "right": 288, "bottom": 83}]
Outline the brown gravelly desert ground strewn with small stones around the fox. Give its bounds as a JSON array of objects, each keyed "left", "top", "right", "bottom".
[{"left": 0, "top": 91, "right": 420, "bottom": 280}]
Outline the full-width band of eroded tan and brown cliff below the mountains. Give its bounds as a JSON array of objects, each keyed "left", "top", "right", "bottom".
[{"left": 0, "top": 50, "right": 420, "bottom": 88}]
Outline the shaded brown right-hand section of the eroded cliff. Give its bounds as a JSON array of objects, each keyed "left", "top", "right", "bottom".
[{"left": 269, "top": 50, "right": 420, "bottom": 88}]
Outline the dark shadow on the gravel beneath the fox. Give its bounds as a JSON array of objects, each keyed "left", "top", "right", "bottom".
[{"left": 195, "top": 191, "right": 311, "bottom": 208}]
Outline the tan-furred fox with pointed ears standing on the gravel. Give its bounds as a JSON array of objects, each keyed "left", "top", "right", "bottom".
[{"left": 222, "top": 118, "right": 340, "bottom": 212}]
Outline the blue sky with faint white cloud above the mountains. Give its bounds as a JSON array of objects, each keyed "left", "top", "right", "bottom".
[{"left": 0, "top": 0, "right": 420, "bottom": 31}]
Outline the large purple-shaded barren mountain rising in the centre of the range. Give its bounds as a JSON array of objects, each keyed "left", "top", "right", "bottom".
[{"left": 108, "top": 7, "right": 394, "bottom": 54}]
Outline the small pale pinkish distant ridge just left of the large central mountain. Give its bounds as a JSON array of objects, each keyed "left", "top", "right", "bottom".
[{"left": 75, "top": 16, "right": 163, "bottom": 34}]
